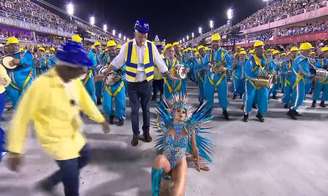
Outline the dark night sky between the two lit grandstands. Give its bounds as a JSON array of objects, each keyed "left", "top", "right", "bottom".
[{"left": 47, "top": 0, "right": 265, "bottom": 41}]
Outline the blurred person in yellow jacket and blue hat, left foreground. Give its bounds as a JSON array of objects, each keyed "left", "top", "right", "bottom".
[{"left": 7, "top": 41, "right": 109, "bottom": 196}]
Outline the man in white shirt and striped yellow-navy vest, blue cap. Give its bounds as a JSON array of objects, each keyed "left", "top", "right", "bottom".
[{"left": 110, "top": 20, "right": 168, "bottom": 146}]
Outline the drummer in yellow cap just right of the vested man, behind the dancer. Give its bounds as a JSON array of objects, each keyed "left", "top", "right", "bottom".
[{"left": 164, "top": 44, "right": 187, "bottom": 99}]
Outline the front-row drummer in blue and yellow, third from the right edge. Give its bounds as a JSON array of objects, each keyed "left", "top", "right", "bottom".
[{"left": 243, "top": 40, "right": 270, "bottom": 122}]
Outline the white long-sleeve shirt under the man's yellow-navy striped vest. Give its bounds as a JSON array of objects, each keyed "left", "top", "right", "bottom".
[{"left": 111, "top": 39, "right": 168, "bottom": 82}]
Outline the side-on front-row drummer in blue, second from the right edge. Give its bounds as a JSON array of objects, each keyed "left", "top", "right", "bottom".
[{"left": 287, "top": 42, "right": 314, "bottom": 120}]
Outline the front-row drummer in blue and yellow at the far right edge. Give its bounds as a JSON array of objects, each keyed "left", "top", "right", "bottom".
[{"left": 312, "top": 46, "right": 328, "bottom": 108}]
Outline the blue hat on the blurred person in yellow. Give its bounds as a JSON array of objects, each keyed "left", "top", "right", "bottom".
[{"left": 56, "top": 41, "right": 92, "bottom": 67}]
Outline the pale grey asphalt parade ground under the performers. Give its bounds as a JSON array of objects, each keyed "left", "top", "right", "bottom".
[{"left": 0, "top": 88, "right": 328, "bottom": 196}]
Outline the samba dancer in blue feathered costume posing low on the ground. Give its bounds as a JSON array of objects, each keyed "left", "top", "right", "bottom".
[{"left": 151, "top": 96, "right": 213, "bottom": 196}]
